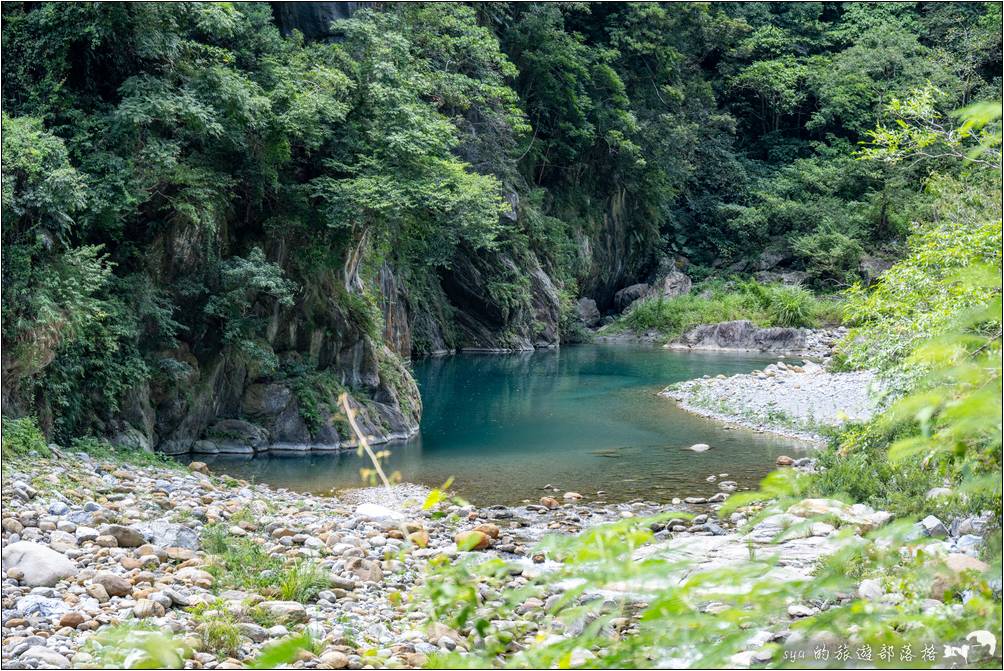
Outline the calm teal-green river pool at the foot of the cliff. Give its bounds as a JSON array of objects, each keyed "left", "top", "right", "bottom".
[{"left": 199, "top": 345, "right": 804, "bottom": 504}]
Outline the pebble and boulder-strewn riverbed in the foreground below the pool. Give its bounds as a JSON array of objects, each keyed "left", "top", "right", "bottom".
[{"left": 2, "top": 453, "right": 979, "bottom": 669}]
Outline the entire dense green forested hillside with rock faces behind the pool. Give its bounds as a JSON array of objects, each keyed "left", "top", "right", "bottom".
[{"left": 2, "top": 3, "right": 1001, "bottom": 453}]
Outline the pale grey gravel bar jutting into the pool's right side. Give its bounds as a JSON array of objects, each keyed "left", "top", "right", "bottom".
[{"left": 662, "top": 361, "right": 882, "bottom": 442}]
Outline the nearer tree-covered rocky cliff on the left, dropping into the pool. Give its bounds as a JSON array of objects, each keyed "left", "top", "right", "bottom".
[{"left": 2, "top": 2, "right": 652, "bottom": 454}]
